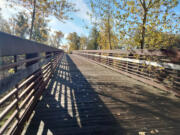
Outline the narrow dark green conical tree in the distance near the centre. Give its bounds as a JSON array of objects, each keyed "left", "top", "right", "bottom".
[{"left": 87, "top": 26, "right": 99, "bottom": 50}]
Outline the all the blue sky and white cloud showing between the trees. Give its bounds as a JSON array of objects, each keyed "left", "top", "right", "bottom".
[{"left": 0, "top": 0, "right": 180, "bottom": 44}]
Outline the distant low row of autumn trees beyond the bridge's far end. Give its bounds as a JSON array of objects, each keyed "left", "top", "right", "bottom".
[{"left": 67, "top": 26, "right": 121, "bottom": 52}]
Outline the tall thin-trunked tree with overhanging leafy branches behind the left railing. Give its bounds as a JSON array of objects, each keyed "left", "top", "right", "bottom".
[{"left": 11, "top": 0, "right": 77, "bottom": 39}]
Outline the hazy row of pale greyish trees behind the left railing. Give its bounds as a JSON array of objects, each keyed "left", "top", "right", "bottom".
[{"left": 0, "top": 12, "right": 64, "bottom": 48}]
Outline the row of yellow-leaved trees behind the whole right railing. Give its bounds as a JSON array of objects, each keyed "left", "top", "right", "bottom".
[{"left": 68, "top": 0, "right": 180, "bottom": 50}]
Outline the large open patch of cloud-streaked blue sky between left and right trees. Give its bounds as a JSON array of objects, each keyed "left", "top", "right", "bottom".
[{"left": 49, "top": 0, "right": 91, "bottom": 37}]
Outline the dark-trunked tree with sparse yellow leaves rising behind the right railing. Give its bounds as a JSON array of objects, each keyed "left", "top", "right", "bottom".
[{"left": 114, "top": 0, "right": 178, "bottom": 49}]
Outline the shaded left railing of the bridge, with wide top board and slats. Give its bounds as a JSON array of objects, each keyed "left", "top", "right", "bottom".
[{"left": 0, "top": 32, "right": 63, "bottom": 135}]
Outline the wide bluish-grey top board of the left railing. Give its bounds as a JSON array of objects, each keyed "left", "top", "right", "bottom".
[{"left": 0, "top": 32, "right": 59, "bottom": 57}]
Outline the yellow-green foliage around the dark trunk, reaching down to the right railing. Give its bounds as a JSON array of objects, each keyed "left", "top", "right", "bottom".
[{"left": 114, "top": 0, "right": 180, "bottom": 49}]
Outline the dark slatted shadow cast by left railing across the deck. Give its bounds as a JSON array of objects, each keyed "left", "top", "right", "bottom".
[{"left": 24, "top": 56, "right": 125, "bottom": 135}]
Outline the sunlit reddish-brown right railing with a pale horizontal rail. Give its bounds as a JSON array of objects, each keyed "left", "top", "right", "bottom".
[{"left": 73, "top": 49, "right": 180, "bottom": 95}]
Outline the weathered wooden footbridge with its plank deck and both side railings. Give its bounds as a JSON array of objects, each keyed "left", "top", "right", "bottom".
[{"left": 0, "top": 33, "right": 180, "bottom": 135}]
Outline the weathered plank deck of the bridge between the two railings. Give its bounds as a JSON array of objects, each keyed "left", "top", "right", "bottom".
[{"left": 22, "top": 55, "right": 180, "bottom": 135}]
